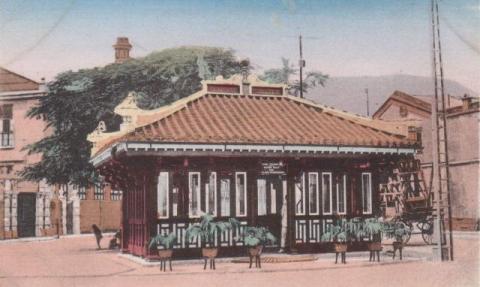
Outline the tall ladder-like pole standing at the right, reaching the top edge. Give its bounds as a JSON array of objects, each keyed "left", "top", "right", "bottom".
[{"left": 431, "top": 0, "right": 453, "bottom": 261}]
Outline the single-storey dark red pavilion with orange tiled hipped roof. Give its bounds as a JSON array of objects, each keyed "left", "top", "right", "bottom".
[{"left": 89, "top": 76, "right": 418, "bottom": 257}]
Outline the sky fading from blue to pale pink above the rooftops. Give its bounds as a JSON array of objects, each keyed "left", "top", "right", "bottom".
[{"left": 0, "top": 0, "right": 480, "bottom": 93}]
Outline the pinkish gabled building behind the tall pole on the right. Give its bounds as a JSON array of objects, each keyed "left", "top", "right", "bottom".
[{"left": 373, "top": 91, "right": 480, "bottom": 230}]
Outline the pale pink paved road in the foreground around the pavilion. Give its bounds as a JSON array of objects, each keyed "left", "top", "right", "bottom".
[{"left": 0, "top": 234, "right": 480, "bottom": 287}]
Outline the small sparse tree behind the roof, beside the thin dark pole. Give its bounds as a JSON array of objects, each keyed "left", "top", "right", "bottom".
[{"left": 260, "top": 58, "right": 328, "bottom": 96}]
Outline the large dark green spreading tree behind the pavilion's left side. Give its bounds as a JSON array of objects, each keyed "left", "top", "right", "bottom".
[{"left": 21, "top": 47, "right": 250, "bottom": 185}]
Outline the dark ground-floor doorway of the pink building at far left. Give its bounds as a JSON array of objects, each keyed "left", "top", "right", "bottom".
[{"left": 17, "top": 193, "right": 36, "bottom": 237}]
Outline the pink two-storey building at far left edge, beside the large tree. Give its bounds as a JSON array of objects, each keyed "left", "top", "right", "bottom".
[{"left": 0, "top": 68, "right": 55, "bottom": 239}]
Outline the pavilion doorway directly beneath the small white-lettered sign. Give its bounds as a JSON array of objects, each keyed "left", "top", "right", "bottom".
[{"left": 256, "top": 175, "right": 286, "bottom": 245}]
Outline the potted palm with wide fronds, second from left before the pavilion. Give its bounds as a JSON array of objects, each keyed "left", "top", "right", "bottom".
[{"left": 186, "top": 214, "right": 239, "bottom": 269}]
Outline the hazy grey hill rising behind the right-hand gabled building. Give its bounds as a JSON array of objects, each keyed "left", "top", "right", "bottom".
[{"left": 306, "top": 75, "right": 478, "bottom": 115}]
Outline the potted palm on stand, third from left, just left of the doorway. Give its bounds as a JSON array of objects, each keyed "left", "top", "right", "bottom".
[{"left": 243, "top": 226, "right": 277, "bottom": 268}]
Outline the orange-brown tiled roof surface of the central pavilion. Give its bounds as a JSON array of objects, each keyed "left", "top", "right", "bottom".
[{"left": 114, "top": 93, "right": 413, "bottom": 149}]
